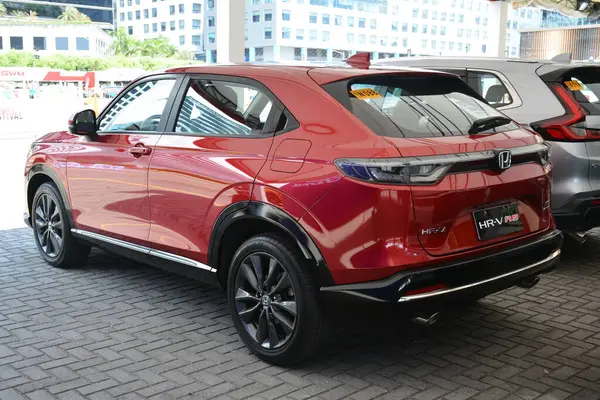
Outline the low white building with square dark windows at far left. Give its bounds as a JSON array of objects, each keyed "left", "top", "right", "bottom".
[{"left": 0, "top": 23, "right": 112, "bottom": 57}]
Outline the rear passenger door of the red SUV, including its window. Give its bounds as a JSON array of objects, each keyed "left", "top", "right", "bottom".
[{"left": 148, "top": 75, "right": 280, "bottom": 263}]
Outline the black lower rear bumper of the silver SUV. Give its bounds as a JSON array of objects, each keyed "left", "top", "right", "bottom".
[{"left": 552, "top": 191, "right": 600, "bottom": 231}]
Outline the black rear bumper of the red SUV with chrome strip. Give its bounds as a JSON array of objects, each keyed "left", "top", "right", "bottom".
[{"left": 321, "top": 230, "right": 562, "bottom": 306}]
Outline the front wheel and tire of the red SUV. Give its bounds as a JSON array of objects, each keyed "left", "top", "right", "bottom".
[{"left": 31, "top": 183, "right": 91, "bottom": 268}]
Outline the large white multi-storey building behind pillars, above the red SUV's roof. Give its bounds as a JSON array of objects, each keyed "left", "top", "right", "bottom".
[{"left": 204, "top": 0, "right": 541, "bottom": 62}]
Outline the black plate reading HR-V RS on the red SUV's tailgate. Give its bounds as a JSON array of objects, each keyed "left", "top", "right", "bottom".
[{"left": 473, "top": 203, "right": 523, "bottom": 240}]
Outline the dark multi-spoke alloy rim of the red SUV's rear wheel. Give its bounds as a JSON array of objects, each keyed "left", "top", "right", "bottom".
[{"left": 235, "top": 253, "right": 298, "bottom": 349}]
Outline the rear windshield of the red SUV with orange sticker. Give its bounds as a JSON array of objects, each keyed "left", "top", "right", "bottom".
[{"left": 323, "top": 74, "right": 517, "bottom": 138}]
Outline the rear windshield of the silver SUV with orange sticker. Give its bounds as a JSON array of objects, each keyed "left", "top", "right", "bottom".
[{"left": 563, "top": 68, "right": 600, "bottom": 115}]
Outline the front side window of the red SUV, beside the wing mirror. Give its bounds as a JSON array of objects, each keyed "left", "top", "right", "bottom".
[{"left": 99, "top": 79, "right": 175, "bottom": 132}]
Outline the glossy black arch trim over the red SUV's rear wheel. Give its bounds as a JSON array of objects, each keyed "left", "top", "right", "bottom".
[{"left": 208, "top": 201, "right": 333, "bottom": 288}]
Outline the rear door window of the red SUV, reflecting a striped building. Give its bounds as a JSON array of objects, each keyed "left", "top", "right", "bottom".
[{"left": 175, "top": 79, "right": 273, "bottom": 136}]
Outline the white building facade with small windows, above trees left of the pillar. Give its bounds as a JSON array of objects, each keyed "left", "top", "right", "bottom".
[{"left": 115, "top": 0, "right": 205, "bottom": 58}]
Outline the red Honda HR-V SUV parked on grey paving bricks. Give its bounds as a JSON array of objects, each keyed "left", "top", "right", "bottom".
[{"left": 25, "top": 54, "right": 562, "bottom": 364}]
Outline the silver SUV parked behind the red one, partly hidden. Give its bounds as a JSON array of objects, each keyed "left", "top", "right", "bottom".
[{"left": 378, "top": 57, "right": 600, "bottom": 240}]
